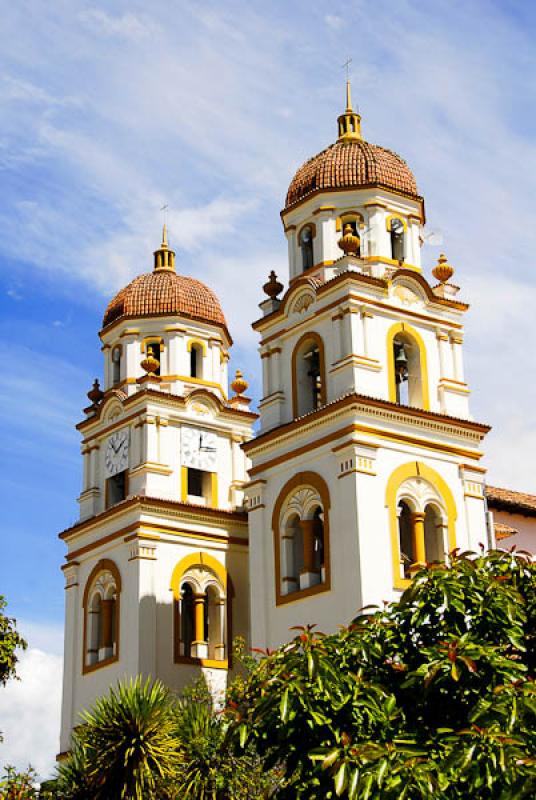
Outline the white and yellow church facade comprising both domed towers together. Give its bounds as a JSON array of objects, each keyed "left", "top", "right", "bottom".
[{"left": 57, "top": 85, "right": 495, "bottom": 752}]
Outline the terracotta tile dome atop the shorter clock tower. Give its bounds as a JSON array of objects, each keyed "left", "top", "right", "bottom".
[{"left": 102, "top": 270, "right": 227, "bottom": 329}]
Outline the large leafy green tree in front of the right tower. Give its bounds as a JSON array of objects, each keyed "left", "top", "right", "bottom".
[{"left": 227, "top": 551, "right": 536, "bottom": 800}]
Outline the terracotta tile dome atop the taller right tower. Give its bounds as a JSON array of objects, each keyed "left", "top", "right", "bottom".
[{"left": 285, "top": 139, "right": 419, "bottom": 210}]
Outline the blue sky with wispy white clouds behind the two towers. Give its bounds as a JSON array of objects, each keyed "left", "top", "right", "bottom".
[{"left": 0, "top": 0, "right": 536, "bottom": 770}]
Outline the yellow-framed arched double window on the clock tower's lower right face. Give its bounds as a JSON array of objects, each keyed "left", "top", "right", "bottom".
[{"left": 171, "top": 553, "right": 229, "bottom": 667}]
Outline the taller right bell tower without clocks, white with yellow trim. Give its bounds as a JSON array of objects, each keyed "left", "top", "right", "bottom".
[{"left": 243, "top": 83, "right": 491, "bottom": 647}]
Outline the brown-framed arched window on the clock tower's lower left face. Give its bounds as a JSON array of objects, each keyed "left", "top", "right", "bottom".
[{"left": 82, "top": 559, "right": 121, "bottom": 672}]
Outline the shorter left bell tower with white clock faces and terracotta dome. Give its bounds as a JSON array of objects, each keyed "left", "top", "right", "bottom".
[{"left": 60, "top": 227, "right": 256, "bottom": 752}]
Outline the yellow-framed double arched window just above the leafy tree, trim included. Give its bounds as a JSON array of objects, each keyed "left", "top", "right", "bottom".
[{"left": 386, "top": 461, "right": 457, "bottom": 589}]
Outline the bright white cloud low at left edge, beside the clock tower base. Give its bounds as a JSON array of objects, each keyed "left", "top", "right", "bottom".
[{"left": 0, "top": 622, "right": 63, "bottom": 778}]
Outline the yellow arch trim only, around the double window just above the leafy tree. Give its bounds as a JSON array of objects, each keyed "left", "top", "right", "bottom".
[{"left": 385, "top": 461, "right": 458, "bottom": 589}]
